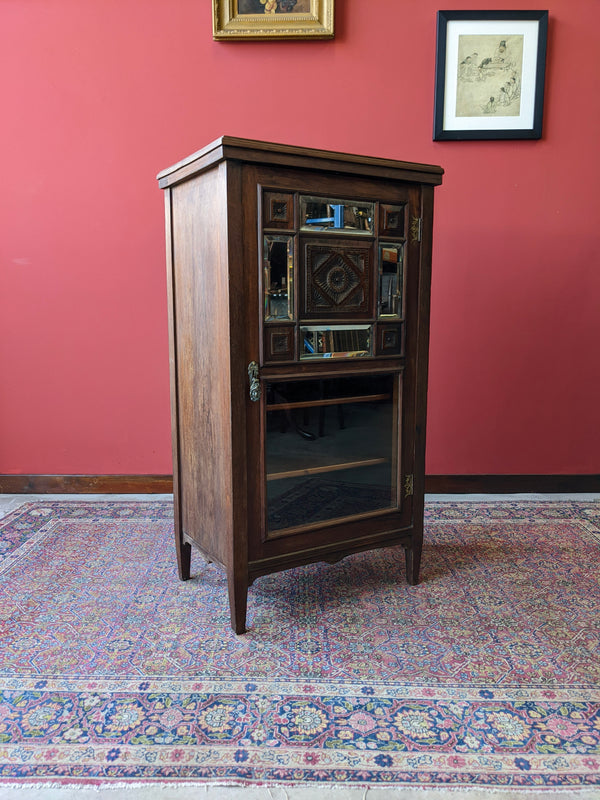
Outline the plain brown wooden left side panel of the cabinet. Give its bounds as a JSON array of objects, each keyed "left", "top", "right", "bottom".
[{"left": 172, "top": 165, "right": 232, "bottom": 565}]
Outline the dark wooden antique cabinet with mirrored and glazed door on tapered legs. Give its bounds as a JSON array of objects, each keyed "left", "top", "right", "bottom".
[{"left": 158, "top": 136, "right": 443, "bottom": 633}]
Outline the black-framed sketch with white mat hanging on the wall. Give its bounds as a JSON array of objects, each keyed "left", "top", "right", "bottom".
[{"left": 433, "top": 11, "right": 548, "bottom": 140}]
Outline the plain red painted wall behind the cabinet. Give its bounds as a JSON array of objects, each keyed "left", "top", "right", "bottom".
[{"left": 0, "top": 0, "right": 600, "bottom": 474}]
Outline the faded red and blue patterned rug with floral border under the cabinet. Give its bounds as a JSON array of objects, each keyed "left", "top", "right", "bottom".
[{"left": 0, "top": 501, "right": 600, "bottom": 790}]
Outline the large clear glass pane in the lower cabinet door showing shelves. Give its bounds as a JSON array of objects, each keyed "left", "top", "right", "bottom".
[{"left": 265, "top": 373, "right": 402, "bottom": 535}]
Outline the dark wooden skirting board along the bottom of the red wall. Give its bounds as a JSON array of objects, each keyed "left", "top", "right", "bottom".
[{"left": 0, "top": 475, "right": 600, "bottom": 494}]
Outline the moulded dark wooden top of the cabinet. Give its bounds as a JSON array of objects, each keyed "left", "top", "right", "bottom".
[{"left": 157, "top": 136, "right": 444, "bottom": 189}]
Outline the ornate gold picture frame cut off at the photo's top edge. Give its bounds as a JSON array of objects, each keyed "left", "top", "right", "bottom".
[{"left": 212, "top": 0, "right": 334, "bottom": 42}]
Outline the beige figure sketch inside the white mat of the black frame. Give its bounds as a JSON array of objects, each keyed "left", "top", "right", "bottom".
[{"left": 456, "top": 34, "right": 524, "bottom": 117}]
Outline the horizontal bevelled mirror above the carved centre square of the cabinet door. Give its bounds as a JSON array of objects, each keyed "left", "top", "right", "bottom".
[{"left": 300, "top": 195, "right": 375, "bottom": 236}]
